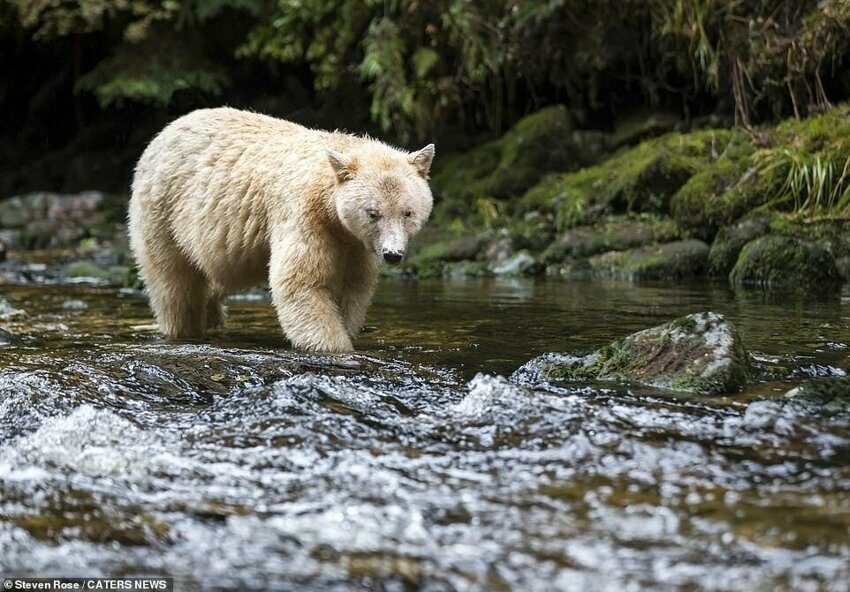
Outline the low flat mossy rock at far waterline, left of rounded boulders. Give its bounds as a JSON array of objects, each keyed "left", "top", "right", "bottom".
[{"left": 590, "top": 239, "right": 709, "bottom": 281}]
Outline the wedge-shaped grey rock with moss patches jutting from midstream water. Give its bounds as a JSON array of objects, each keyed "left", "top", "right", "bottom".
[{"left": 513, "top": 312, "right": 749, "bottom": 395}]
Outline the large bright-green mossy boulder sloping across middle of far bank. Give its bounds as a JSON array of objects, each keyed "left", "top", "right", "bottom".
[{"left": 520, "top": 130, "right": 751, "bottom": 231}]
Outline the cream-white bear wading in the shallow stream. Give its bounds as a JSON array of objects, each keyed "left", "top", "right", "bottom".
[{"left": 128, "top": 107, "right": 435, "bottom": 352}]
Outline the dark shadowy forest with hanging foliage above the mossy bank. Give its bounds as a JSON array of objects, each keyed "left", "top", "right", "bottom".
[{"left": 0, "top": 0, "right": 850, "bottom": 198}]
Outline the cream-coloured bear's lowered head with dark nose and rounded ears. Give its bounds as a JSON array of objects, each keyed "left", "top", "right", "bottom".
[{"left": 328, "top": 143, "right": 434, "bottom": 263}]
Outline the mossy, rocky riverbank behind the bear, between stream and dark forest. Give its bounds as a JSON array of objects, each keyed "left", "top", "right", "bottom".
[{"left": 0, "top": 105, "right": 850, "bottom": 290}]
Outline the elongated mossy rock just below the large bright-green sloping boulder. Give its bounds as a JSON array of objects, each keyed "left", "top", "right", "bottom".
[{"left": 541, "top": 215, "right": 680, "bottom": 264}]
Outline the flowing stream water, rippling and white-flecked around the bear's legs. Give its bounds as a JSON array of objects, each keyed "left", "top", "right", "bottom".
[{"left": 0, "top": 280, "right": 850, "bottom": 592}]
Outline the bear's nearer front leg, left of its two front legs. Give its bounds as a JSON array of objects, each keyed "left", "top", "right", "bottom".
[{"left": 269, "top": 245, "right": 354, "bottom": 352}]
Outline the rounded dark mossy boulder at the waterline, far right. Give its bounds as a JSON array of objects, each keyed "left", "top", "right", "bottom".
[{"left": 729, "top": 235, "right": 838, "bottom": 288}]
